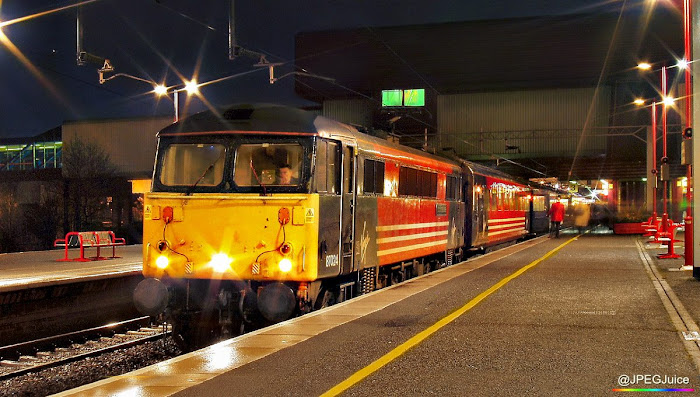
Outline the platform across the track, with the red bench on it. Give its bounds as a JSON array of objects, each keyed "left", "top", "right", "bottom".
[{"left": 0, "top": 245, "right": 143, "bottom": 346}]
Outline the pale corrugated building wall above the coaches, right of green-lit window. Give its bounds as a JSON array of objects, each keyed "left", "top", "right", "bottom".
[{"left": 438, "top": 87, "right": 610, "bottom": 159}]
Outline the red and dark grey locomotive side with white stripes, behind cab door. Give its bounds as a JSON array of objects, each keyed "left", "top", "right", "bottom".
[{"left": 334, "top": 125, "right": 464, "bottom": 286}]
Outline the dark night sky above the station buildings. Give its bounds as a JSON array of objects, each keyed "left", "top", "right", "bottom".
[{"left": 0, "top": 0, "right": 632, "bottom": 138}]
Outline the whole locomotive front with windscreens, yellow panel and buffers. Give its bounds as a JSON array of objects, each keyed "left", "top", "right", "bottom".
[{"left": 135, "top": 131, "right": 319, "bottom": 339}]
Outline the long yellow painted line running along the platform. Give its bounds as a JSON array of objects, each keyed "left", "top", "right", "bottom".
[{"left": 321, "top": 236, "right": 579, "bottom": 397}]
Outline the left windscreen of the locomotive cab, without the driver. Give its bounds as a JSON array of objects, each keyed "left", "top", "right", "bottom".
[{"left": 160, "top": 143, "right": 226, "bottom": 187}]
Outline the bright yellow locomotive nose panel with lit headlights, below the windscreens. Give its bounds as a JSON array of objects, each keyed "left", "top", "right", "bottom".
[{"left": 143, "top": 193, "right": 318, "bottom": 282}]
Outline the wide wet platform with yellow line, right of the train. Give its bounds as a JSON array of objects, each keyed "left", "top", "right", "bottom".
[{"left": 54, "top": 233, "right": 700, "bottom": 396}]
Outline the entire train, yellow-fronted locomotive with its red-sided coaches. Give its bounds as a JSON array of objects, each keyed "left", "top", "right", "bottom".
[{"left": 134, "top": 105, "right": 552, "bottom": 348}]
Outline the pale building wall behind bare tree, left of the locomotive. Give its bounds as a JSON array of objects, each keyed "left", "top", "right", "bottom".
[{"left": 63, "top": 117, "right": 173, "bottom": 178}]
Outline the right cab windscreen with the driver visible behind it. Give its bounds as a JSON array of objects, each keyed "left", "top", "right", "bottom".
[{"left": 233, "top": 143, "right": 304, "bottom": 187}]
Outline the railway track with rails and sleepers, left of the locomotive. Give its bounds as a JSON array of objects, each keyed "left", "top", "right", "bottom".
[{"left": 0, "top": 317, "right": 171, "bottom": 381}]
